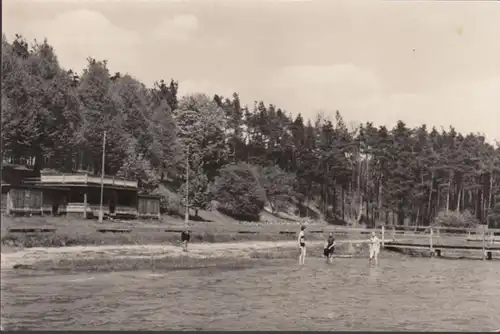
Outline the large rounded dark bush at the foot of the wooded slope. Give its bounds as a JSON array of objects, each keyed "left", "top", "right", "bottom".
[{"left": 211, "top": 164, "right": 266, "bottom": 221}]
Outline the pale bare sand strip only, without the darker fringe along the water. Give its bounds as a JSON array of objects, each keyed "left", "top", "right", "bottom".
[{"left": 1, "top": 239, "right": 367, "bottom": 269}]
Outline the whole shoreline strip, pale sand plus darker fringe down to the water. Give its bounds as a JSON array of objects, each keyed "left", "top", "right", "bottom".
[{"left": 1, "top": 240, "right": 366, "bottom": 271}]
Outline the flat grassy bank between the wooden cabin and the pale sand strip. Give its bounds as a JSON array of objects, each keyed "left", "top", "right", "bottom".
[{"left": 1, "top": 217, "right": 352, "bottom": 248}]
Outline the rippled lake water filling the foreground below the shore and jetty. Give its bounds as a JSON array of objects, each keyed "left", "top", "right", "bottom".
[{"left": 2, "top": 257, "right": 500, "bottom": 331}]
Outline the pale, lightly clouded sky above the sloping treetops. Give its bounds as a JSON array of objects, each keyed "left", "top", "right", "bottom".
[{"left": 2, "top": 0, "right": 500, "bottom": 142}]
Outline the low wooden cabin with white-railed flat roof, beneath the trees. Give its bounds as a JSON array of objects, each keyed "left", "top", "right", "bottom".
[{"left": 1, "top": 161, "right": 160, "bottom": 219}]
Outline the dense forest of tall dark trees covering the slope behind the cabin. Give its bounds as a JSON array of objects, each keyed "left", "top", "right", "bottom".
[{"left": 1, "top": 35, "right": 500, "bottom": 228}]
